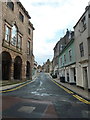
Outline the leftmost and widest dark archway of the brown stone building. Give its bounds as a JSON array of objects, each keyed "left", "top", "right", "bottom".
[{"left": 2, "top": 51, "right": 12, "bottom": 80}]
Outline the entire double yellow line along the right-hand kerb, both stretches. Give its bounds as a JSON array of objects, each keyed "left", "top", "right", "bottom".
[{"left": 51, "top": 80, "right": 90, "bottom": 104}]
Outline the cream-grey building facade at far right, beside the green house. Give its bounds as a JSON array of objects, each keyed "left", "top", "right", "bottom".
[{"left": 74, "top": 5, "right": 90, "bottom": 89}]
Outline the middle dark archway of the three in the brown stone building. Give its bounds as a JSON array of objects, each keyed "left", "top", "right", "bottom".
[{"left": 14, "top": 56, "right": 22, "bottom": 80}]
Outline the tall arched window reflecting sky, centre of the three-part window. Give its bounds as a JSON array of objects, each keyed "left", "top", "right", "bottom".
[{"left": 11, "top": 25, "right": 17, "bottom": 46}]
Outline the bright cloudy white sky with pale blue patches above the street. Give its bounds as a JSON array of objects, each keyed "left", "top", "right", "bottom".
[{"left": 20, "top": 0, "right": 89, "bottom": 65}]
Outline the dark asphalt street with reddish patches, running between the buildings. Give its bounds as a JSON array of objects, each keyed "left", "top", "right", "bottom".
[{"left": 2, "top": 73, "right": 90, "bottom": 118}]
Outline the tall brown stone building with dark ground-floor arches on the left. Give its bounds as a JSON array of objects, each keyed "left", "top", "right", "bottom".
[{"left": 0, "top": 0, "right": 34, "bottom": 80}]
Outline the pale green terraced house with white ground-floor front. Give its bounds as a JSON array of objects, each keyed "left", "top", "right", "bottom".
[{"left": 59, "top": 31, "right": 76, "bottom": 84}]
